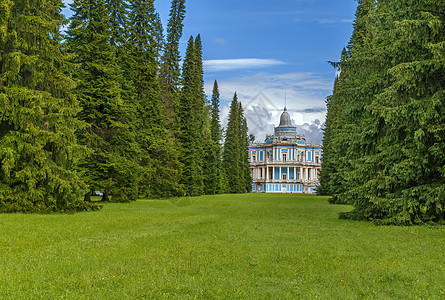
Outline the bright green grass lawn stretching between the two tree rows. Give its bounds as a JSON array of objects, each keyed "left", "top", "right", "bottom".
[{"left": 0, "top": 194, "right": 445, "bottom": 299}]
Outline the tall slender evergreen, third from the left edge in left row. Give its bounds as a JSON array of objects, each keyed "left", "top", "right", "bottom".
[{"left": 127, "top": 0, "right": 180, "bottom": 197}]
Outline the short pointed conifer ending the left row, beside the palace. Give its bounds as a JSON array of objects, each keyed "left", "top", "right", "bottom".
[{"left": 223, "top": 93, "right": 252, "bottom": 193}]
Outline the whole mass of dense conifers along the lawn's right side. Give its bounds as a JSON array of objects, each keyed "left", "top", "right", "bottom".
[{"left": 319, "top": 0, "right": 445, "bottom": 225}]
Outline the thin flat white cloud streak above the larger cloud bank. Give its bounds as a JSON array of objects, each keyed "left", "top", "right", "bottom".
[{"left": 203, "top": 58, "right": 284, "bottom": 72}]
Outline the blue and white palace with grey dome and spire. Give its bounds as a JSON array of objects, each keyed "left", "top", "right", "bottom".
[{"left": 249, "top": 108, "right": 323, "bottom": 193}]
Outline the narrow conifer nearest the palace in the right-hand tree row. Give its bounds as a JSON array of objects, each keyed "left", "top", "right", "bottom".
[{"left": 319, "top": 0, "right": 375, "bottom": 204}]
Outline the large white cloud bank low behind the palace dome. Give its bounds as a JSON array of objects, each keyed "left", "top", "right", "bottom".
[{"left": 205, "top": 72, "right": 333, "bottom": 142}]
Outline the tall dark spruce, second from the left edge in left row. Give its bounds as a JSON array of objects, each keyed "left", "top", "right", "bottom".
[{"left": 67, "top": 0, "right": 140, "bottom": 201}]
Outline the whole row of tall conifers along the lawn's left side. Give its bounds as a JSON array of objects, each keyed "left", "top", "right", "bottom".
[{"left": 0, "top": 0, "right": 251, "bottom": 212}]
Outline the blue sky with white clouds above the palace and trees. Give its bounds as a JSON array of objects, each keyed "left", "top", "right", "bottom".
[{"left": 64, "top": 0, "right": 357, "bottom": 142}]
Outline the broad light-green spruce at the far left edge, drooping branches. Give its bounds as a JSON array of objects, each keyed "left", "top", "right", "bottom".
[{"left": 0, "top": 0, "right": 98, "bottom": 213}]
